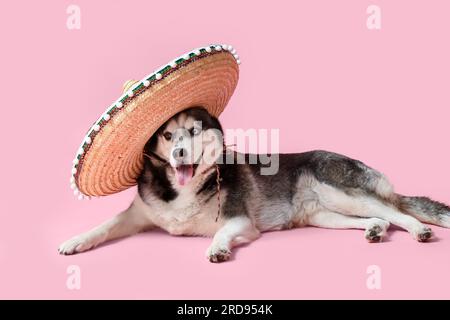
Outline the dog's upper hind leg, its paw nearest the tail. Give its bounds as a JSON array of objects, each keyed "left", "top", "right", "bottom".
[{"left": 315, "top": 184, "right": 432, "bottom": 241}]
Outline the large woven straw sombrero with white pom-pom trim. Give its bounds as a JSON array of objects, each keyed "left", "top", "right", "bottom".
[{"left": 70, "top": 45, "right": 240, "bottom": 200}]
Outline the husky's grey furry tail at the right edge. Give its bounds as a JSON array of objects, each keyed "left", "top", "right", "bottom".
[{"left": 395, "top": 194, "right": 450, "bottom": 228}]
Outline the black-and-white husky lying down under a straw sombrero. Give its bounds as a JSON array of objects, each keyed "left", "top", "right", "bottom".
[{"left": 59, "top": 107, "right": 450, "bottom": 262}]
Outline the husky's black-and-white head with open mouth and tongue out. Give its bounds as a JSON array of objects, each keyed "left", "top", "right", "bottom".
[{"left": 144, "top": 107, "right": 223, "bottom": 186}]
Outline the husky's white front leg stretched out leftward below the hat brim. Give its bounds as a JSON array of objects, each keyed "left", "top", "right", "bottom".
[{"left": 58, "top": 204, "right": 151, "bottom": 255}]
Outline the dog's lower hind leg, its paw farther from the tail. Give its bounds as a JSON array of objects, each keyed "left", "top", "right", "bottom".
[{"left": 307, "top": 210, "right": 389, "bottom": 242}]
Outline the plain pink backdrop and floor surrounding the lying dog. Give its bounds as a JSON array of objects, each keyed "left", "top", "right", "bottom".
[{"left": 0, "top": 0, "right": 450, "bottom": 299}]
